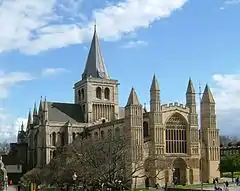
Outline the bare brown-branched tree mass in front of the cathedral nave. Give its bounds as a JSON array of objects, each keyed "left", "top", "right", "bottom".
[{"left": 42, "top": 132, "right": 160, "bottom": 188}]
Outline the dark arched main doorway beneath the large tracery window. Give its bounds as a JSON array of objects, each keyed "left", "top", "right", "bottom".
[{"left": 173, "top": 158, "right": 187, "bottom": 185}]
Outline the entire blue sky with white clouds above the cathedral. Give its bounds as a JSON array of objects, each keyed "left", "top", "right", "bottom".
[{"left": 0, "top": 0, "right": 240, "bottom": 140}]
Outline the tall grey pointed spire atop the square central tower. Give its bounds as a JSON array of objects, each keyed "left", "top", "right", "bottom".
[{"left": 82, "top": 24, "right": 109, "bottom": 79}]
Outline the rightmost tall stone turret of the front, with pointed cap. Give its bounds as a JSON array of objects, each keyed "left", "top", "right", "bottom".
[{"left": 201, "top": 85, "right": 220, "bottom": 181}]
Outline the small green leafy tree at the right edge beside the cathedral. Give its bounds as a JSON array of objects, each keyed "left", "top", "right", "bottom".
[{"left": 219, "top": 153, "right": 240, "bottom": 181}]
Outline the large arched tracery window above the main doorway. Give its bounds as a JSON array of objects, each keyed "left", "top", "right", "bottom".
[{"left": 166, "top": 113, "right": 187, "bottom": 153}]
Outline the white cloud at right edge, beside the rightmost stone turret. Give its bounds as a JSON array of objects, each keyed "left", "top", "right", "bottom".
[{"left": 212, "top": 74, "right": 240, "bottom": 136}]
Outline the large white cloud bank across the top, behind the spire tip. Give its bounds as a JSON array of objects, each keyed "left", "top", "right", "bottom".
[{"left": 0, "top": 0, "right": 187, "bottom": 54}]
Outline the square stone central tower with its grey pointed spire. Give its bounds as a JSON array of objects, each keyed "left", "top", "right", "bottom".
[{"left": 74, "top": 26, "right": 119, "bottom": 123}]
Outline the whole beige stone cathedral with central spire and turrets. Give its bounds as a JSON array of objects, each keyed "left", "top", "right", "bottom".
[{"left": 23, "top": 26, "right": 220, "bottom": 187}]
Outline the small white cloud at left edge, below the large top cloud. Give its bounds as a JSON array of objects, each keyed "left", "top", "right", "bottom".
[{"left": 0, "top": 71, "right": 34, "bottom": 99}]
